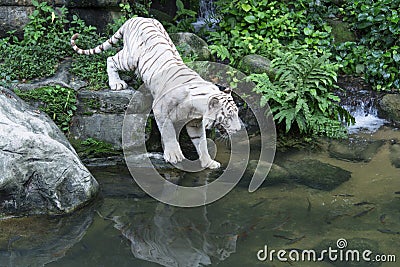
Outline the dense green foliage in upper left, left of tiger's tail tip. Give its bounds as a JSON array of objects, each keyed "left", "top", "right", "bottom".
[{"left": 0, "top": 0, "right": 95, "bottom": 80}]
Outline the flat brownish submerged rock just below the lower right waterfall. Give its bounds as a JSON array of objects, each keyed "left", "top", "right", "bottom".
[{"left": 328, "top": 139, "right": 384, "bottom": 162}]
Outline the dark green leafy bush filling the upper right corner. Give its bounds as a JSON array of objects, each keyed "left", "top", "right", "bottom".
[{"left": 336, "top": 0, "right": 400, "bottom": 90}]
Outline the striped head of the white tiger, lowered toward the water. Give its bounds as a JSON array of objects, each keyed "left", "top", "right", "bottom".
[{"left": 204, "top": 88, "right": 242, "bottom": 134}]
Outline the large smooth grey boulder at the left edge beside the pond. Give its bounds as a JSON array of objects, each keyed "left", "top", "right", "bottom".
[{"left": 0, "top": 87, "right": 98, "bottom": 215}]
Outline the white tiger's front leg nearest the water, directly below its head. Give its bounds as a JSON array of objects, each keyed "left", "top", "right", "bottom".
[{"left": 186, "top": 122, "right": 221, "bottom": 169}]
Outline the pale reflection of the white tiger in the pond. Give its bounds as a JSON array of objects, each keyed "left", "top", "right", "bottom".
[{"left": 114, "top": 204, "right": 239, "bottom": 267}]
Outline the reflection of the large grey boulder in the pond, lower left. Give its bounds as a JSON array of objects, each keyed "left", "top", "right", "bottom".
[{"left": 0, "top": 204, "right": 95, "bottom": 266}]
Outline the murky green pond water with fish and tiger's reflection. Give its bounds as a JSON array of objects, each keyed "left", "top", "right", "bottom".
[{"left": 0, "top": 127, "right": 400, "bottom": 267}]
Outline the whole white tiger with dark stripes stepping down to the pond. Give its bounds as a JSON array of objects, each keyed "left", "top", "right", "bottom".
[{"left": 71, "top": 17, "right": 241, "bottom": 169}]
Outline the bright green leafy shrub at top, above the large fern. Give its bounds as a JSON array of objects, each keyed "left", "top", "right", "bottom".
[{"left": 209, "top": 0, "right": 332, "bottom": 65}]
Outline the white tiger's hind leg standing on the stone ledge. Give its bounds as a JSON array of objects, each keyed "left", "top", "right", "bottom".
[{"left": 107, "top": 49, "right": 128, "bottom": 90}]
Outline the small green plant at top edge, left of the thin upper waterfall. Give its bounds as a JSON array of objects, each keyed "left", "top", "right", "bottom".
[{"left": 166, "top": 0, "right": 197, "bottom": 32}]
